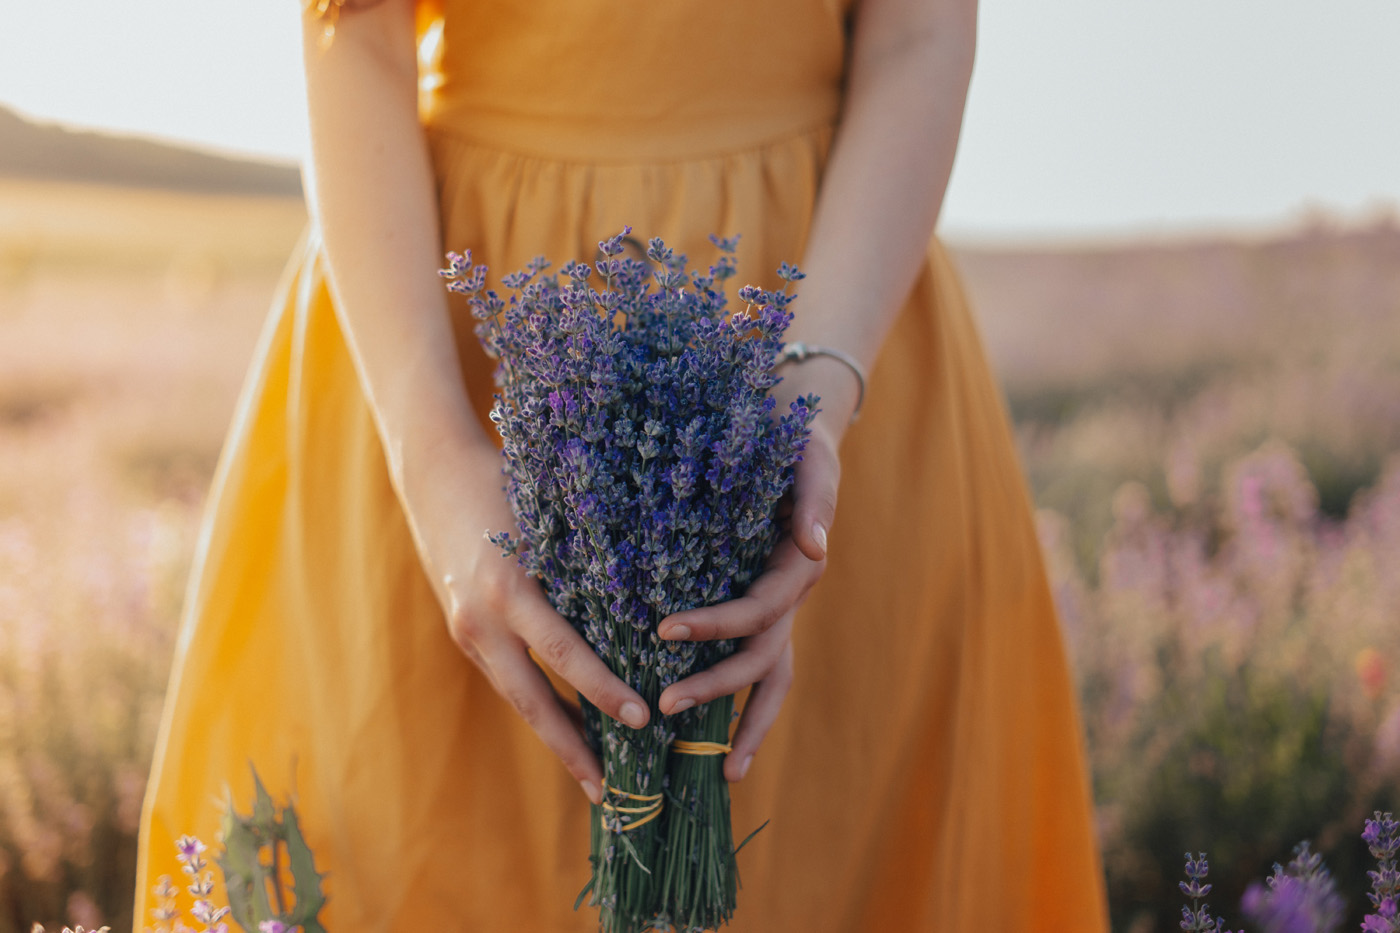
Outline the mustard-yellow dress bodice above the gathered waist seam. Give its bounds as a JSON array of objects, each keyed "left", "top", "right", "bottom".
[{"left": 424, "top": 0, "right": 847, "bottom": 163}]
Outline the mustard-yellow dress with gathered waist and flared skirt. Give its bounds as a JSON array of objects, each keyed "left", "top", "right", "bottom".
[{"left": 136, "top": 0, "right": 1106, "bottom": 933}]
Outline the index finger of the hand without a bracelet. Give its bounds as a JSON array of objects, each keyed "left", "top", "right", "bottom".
[{"left": 514, "top": 597, "right": 651, "bottom": 728}]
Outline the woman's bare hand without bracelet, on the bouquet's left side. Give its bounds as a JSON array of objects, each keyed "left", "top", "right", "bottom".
[{"left": 402, "top": 431, "right": 650, "bottom": 803}]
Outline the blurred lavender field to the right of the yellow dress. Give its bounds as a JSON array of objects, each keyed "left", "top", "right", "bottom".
[{"left": 962, "top": 217, "right": 1400, "bottom": 933}]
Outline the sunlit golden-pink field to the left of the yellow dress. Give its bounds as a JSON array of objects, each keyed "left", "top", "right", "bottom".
[{"left": 0, "top": 179, "right": 304, "bottom": 933}]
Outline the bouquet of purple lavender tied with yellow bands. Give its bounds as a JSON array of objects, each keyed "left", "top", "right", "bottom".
[{"left": 442, "top": 228, "right": 816, "bottom": 933}]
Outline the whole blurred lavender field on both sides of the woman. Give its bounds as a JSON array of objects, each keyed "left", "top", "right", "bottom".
[{"left": 0, "top": 181, "right": 1400, "bottom": 933}]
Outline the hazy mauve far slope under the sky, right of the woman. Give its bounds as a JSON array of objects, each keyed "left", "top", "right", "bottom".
[{"left": 951, "top": 216, "right": 1400, "bottom": 401}]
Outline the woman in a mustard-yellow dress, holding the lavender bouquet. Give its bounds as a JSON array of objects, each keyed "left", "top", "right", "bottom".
[{"left": 137, "top": 0, "right": 1105, "bottom": 933}]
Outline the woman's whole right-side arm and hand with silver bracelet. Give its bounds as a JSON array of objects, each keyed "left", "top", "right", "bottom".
[{"left": 661, "top": 0, "right": 977, "bottom": 780}]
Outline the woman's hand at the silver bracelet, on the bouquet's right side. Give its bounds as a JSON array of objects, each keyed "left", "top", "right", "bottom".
[{"left": 658, "top": 357, "right": 857, "bottom": 780}]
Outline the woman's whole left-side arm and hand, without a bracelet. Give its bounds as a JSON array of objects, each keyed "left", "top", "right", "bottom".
[{"left": 302, "top": 0, "right": 647, "bottom": 803}]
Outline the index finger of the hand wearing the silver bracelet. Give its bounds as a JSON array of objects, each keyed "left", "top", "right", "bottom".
[{"left": 657, "top": 538, "right": 826, "bottom": 642}]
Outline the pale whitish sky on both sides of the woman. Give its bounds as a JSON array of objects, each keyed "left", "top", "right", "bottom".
[{"left": 0, "top": 0, "right": 1400, "bottom": 240}]
